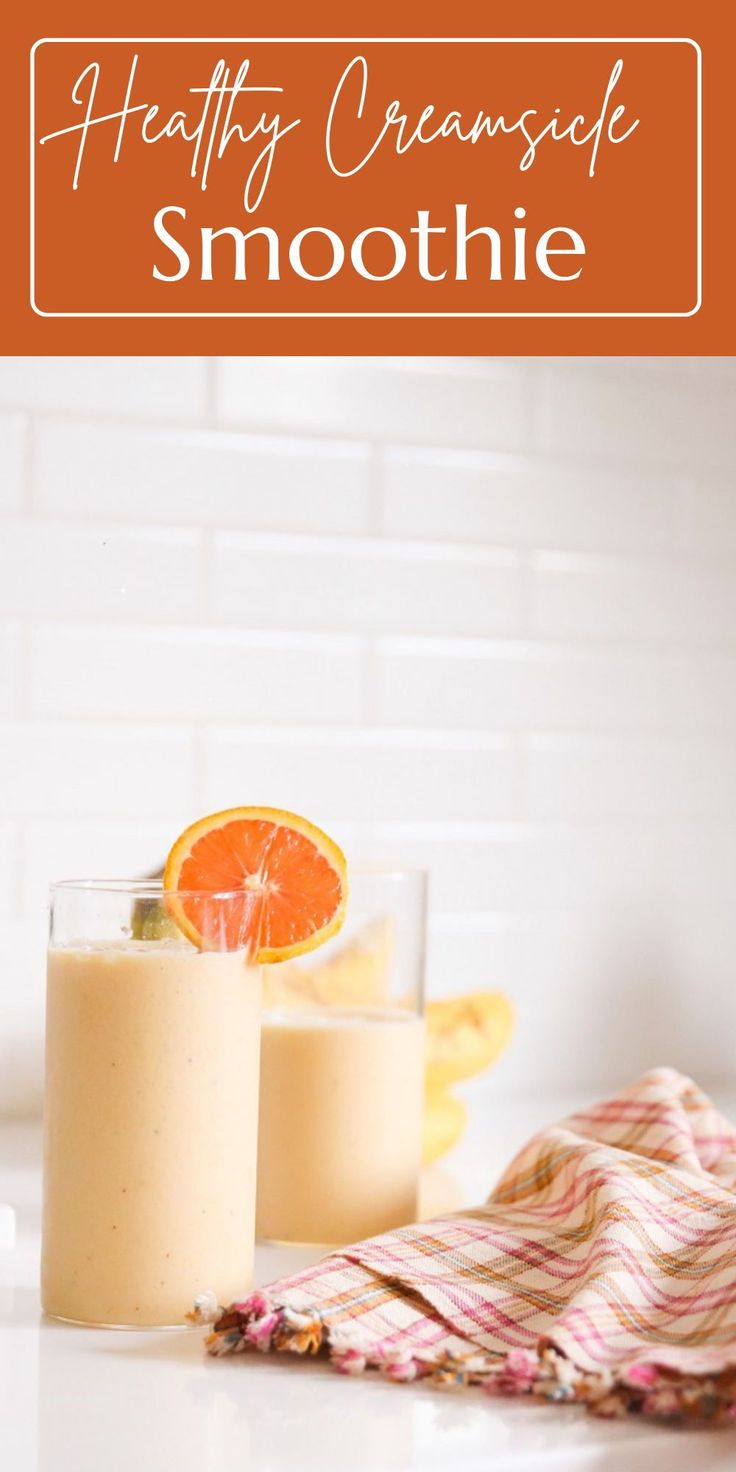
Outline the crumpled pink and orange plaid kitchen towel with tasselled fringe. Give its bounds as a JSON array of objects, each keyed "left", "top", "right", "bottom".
[{"left": 194, "top": 1069, "right": 736, "bottom": 1425}]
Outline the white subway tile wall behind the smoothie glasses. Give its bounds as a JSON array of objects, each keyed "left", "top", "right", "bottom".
[{"left": 0, "top": 358, "right": 736, "bottom": 1111}]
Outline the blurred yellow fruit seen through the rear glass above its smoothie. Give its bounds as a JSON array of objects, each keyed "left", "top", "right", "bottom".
[{"left": 263, "top": 916, "right": 393, "bottom": 1007}]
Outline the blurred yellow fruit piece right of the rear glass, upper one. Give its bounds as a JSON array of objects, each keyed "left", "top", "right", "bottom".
[{"left": 427, "top": 992, "right": 514, "bottom": 1088}]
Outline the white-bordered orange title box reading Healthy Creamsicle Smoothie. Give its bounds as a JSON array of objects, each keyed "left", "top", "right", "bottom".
[{"left": 28, "top": 37, "right": 702, "bottom": 321}]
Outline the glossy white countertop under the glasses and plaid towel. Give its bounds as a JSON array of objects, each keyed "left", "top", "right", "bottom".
[{"left": 0, "top": 1101, "right": 736, "bottom": 1472}]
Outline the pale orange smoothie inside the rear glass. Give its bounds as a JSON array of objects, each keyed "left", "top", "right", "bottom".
[{"left": 256, "top": 1007, "right": 424, "bottom": 1244}]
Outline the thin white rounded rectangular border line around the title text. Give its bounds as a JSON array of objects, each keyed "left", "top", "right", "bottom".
[{"left": 29, "top": 35, "right": 702, "bottom": 319}]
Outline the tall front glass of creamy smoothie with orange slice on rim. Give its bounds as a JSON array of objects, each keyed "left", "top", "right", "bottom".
[{"left": 41, "top": 880, "right": 261, "bottom": 1328}]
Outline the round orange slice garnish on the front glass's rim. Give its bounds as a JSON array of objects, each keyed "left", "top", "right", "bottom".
[{"left": 163, "top": 808, "right": 347, "bottom": 963}]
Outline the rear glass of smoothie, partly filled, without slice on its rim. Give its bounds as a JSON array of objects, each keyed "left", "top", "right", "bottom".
[{"left": 256, "top": 870, "right": 427, "bottom": 1245}]
